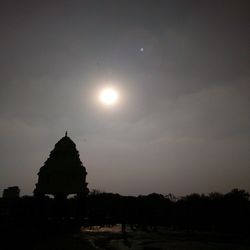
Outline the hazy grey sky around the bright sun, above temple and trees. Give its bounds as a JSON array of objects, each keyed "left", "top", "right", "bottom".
[{"left": 0, "top": 0, "right": 250, "bottom": 195}]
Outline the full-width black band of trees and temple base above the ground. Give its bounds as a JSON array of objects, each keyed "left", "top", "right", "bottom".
[{"left": 0, "top": 189, "right": 250, "bottom": 232}]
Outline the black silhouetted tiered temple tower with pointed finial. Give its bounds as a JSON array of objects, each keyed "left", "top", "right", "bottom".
[{"left": 34, "top": 132, "right": 88, "bottom": 198}]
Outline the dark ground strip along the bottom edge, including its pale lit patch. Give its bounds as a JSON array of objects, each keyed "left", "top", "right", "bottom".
[{"left": 1, "top": 225, "right": 250, "bottom": 250}]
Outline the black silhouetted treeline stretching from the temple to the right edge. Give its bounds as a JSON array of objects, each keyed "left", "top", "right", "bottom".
[{"left": 87, "top": 189, "right": 250, "bottom": 232}]
